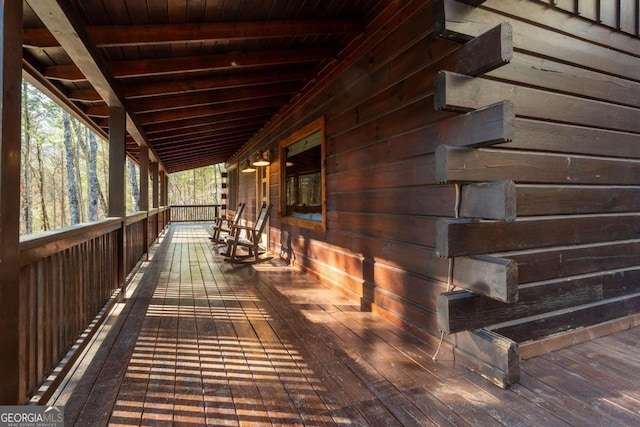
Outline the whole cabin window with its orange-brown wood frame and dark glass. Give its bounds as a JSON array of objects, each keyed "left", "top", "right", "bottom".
[{"left": 280, "top": 117, "right": 327, "bottom": 230}]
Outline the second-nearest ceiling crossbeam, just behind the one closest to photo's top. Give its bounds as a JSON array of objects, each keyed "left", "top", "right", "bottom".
[{"left": 44, "top": 47, "right": 336, "bottom": 81}]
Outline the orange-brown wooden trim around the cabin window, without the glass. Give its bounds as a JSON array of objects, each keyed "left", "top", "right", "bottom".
[{"left": 279, "top": 116, "right": 327, "bottom": 231}]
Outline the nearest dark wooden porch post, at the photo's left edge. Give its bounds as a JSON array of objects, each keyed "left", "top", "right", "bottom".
[{"left": 0, "top": 0, "right": 26, "bottom": 405}]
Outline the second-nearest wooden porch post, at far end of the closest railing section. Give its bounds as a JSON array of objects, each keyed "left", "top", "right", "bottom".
[{"left": 109, "top": 106, "right": 127, "bottom": 298}]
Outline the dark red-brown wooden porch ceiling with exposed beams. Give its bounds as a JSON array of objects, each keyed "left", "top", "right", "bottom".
[{"left": 23, "top": 0, "right": 392, "bottom": 173}]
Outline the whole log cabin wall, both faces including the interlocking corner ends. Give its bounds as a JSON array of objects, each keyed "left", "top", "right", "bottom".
[{"left": 231, "top": 0, "right": 640, "bottom": 386}]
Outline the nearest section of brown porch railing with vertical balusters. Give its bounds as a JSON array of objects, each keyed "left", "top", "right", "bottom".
[{"left": 20, "top": 220, "right": 121, "bottom": 399}]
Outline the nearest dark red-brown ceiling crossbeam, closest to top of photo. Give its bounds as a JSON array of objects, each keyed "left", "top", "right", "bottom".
[{"left": 23, "top": 18, "right": 364, "bottom": 48}]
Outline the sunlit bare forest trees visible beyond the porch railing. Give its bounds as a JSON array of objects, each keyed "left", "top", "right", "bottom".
[{"left": 20, "top": 80, "right": 225, "bottom": 235}]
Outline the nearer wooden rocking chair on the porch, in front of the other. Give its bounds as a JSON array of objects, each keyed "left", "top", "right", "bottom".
[{"left": 224, "top": 203, "right": 273, "bottom": 264}]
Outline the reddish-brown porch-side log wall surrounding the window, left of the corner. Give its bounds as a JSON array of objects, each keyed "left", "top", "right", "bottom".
[{"left": 232, "top": 2, "right": 462, "bottom": 348}]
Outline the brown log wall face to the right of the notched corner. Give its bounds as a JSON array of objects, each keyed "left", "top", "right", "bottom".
[{"left": 436, "top": 0, "right": 640, "bottom": 341}]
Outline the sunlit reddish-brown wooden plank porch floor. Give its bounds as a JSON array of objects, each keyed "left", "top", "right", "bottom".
[{"left": 49, "top": 225, "right": 640, "bottom": 426}]
